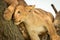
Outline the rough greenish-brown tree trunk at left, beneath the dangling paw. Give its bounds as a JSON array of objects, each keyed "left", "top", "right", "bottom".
[{"left": 0, "top": 0, "right": 24, "bottom": 40}]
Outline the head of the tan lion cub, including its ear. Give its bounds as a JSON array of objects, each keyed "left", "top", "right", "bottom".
[{"left": 13, "top": 5, "right": 34, "bottom": 25}]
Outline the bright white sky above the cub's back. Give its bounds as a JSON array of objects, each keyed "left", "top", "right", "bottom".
[{"left": 25, "top": 0, "right": 60, "bottom": 17}]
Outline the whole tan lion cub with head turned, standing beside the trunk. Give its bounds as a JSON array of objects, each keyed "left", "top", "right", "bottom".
[{"left": 14, "top": 6, "right": 60, "bottom": 40}]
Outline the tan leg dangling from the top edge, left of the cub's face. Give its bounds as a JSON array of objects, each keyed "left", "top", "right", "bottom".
[{"left": 3, "top": 0, "right": 18, "bottom": 20}]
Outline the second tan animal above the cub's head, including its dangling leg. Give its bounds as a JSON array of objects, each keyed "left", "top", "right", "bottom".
[{"left": 3, "top": 0, "right": 27, "bottom": 21}]
